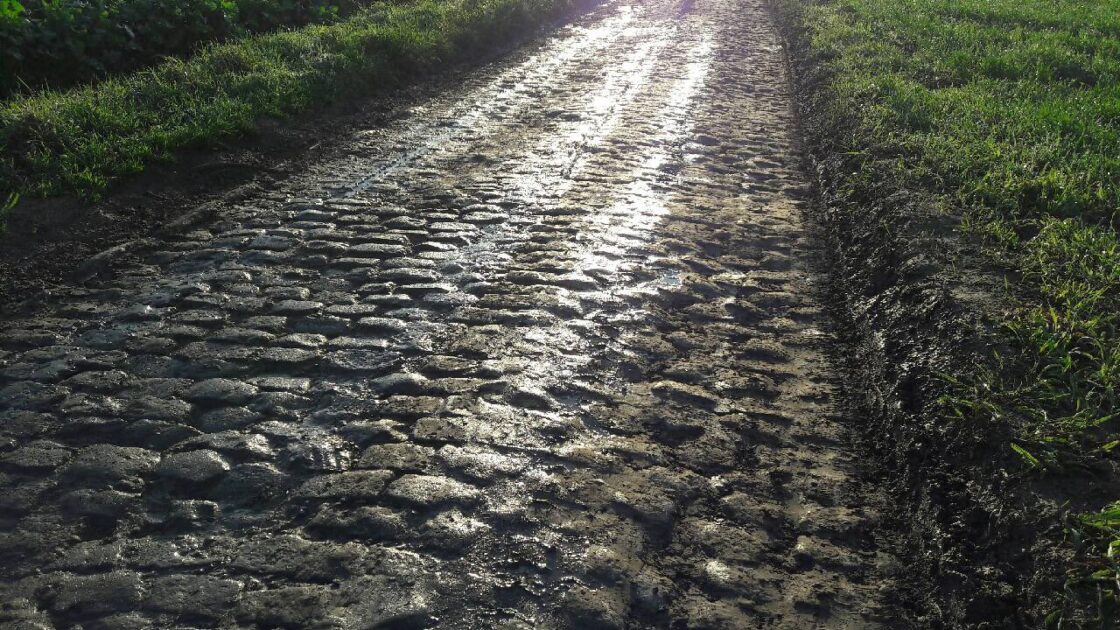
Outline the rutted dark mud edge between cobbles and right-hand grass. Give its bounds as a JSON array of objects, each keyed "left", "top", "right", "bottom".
[{"left": 769, "top": 2, "right": 1073, "bottom": 628}]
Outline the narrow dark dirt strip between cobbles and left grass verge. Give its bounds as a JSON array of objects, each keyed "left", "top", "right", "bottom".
[{"left": 0, "top": 0, "right": 601, "bottom": 313}]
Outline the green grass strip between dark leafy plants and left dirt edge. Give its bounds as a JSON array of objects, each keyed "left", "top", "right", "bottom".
[{"left": 0, "top": 0, "right": 586, "bottom": 200}]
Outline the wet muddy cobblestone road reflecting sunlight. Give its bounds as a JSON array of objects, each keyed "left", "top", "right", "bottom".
[{"left": 0, "top": 0, "right": 893, "bottom": 629}]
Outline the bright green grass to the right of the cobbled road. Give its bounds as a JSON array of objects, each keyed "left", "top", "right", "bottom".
[{"left": 775, "top": 0, "right": 1120, "bottom": 621}]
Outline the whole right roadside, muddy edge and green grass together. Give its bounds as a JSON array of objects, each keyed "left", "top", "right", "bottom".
[{"left": 772, "top": 0, "right": 1120, "bottom": 628}]
